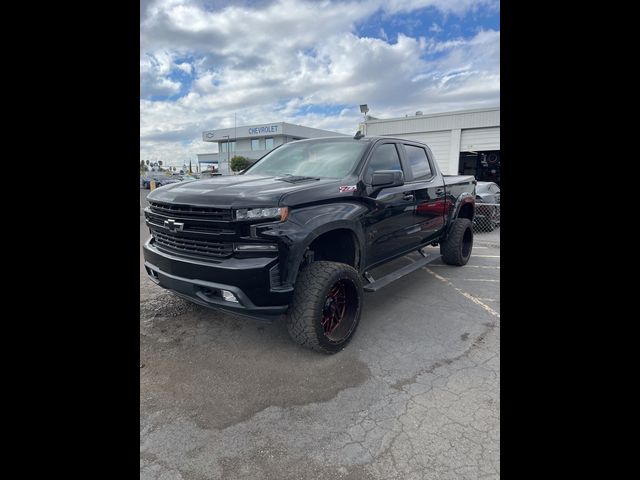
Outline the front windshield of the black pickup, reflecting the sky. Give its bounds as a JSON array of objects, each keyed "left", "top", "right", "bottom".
[{"left": 244, "top": 140, "right": 368, "bottom": 178}]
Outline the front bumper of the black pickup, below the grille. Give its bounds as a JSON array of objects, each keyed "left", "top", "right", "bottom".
[{"left": 143, "top": 238, "right": 293, "bottom": 319}]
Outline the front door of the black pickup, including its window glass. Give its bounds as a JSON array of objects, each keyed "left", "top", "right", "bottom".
[{"left": 362, "top": 141, "right": 416, "bottom": 266}]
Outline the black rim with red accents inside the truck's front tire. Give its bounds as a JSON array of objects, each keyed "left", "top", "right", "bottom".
[{"left": 320, "top": 278, "right": 359, "bottom": 343}]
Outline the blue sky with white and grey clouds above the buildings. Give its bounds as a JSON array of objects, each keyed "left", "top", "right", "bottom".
[{"left": 140, "top": 0, "right": 500, "bottom": 166}]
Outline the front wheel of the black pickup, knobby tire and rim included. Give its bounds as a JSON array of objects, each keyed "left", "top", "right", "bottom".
[{"left": 287, "top": 261, "right": 364, "bottom": 353}]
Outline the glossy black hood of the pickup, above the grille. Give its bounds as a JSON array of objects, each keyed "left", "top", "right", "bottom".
[{"left": 147, "top": 175, "right": 340, "bottom": 208}]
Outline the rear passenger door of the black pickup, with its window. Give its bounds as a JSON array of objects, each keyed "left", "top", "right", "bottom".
[{"left": 401, "top": 142, "right": 446, "bottom": 247}]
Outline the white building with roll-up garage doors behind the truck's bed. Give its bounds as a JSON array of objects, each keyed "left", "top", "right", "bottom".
[{"left": 361, "top": 107, "right": 500, "bottom": 184}]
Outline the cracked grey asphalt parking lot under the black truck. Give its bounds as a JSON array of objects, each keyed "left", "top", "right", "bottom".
[{"left": 140, "top": 190, "right": 500, "bottom": 480}]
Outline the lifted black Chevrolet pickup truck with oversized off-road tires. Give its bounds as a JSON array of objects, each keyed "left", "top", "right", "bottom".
[{"left": 143, "top": 134, "right": 476, "bottom": 353}]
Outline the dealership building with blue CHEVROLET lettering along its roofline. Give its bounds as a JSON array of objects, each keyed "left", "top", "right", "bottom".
[{"left": 198, "top": 122, "right": 343, "bottom": 175}]
